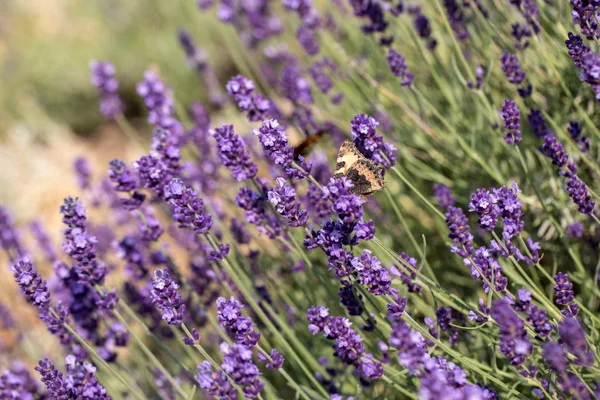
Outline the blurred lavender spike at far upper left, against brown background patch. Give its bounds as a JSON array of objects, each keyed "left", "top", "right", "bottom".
[{"left": 90, "top": 61, "right": 124, "bottom": 119}]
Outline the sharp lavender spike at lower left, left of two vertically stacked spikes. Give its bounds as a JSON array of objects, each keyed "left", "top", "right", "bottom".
[{"left": 151, "top": 269, "right": 186, "bottom": 326}]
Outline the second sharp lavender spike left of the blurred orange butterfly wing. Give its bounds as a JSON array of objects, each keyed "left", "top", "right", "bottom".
[{"left": 210, "top": 125, "right": 258, "bottom": 182}]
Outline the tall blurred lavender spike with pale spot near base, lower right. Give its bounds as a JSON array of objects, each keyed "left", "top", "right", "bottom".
[{"left": 492, "top": 299, "right": 532, "bottom": 365}]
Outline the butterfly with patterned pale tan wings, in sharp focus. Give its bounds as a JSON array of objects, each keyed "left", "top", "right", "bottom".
[{"left": 334, "top": 140, "right": 384, "bottom": 196}]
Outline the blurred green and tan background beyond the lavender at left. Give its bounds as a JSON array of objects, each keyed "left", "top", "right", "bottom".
[{"left": 0, "top": 0, "right": 243, "bottom": 360}]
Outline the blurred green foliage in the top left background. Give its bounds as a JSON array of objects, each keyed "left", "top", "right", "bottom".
[{"left": 0, "top": 0, "right": 235, "bottom": 135}]
